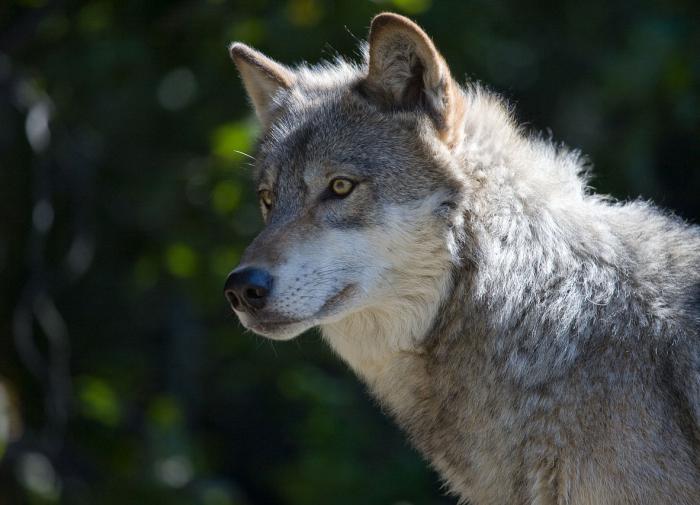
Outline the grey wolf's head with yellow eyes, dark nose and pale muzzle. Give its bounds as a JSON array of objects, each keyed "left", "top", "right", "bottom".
[{"left": 225, "top": 14, "right": 464, "bottom": 339}]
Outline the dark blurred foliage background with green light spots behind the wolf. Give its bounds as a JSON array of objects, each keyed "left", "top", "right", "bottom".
[{"left": 0, "top": 0, "right": 700, "bottom": 505}]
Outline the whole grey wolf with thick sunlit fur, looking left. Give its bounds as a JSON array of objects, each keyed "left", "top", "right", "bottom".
[{"left": 224, "top": 13, "right": 700, "bottom": 505}]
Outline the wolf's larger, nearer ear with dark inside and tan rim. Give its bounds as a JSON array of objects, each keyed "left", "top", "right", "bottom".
[{"left": 365, "top": 12, "right": 462, "bottom": 142}]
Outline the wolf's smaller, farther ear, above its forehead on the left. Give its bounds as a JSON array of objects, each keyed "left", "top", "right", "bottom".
[{"left": 229, "top": 42, "right": 294, "bottom": 125}]
